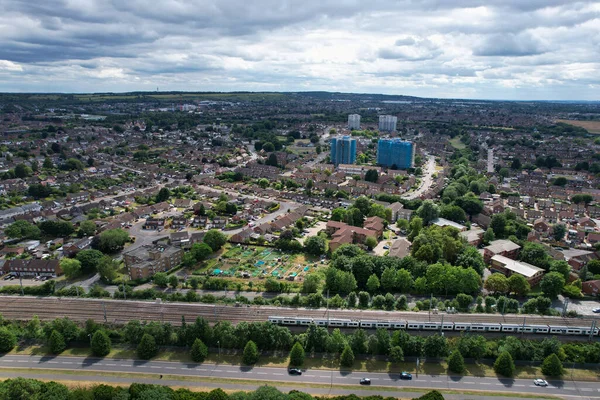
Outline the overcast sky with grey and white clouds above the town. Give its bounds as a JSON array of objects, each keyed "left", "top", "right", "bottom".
[{"left": 0, "top": 0, "right": 600, "bottom": 100}]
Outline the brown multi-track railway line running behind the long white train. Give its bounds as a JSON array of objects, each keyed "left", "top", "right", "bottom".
[{"left": 0, "top": 296, "right": 600, "bottom": 336}]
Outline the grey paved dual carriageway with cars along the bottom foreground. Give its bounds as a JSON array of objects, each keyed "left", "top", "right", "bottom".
[{"left": 0, "top": 355, "right": 600, "bottom": 398}]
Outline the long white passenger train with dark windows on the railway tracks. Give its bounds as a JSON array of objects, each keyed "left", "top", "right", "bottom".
[{"left": 269, "top": 316, "right": 600, "bottom": 336}]
